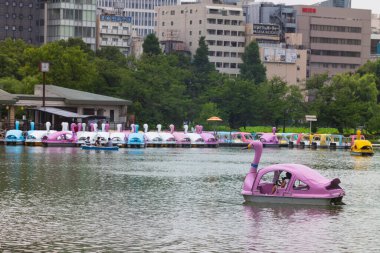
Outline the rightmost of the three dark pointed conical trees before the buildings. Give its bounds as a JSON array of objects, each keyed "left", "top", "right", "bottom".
[{"left": 240, "top": 41, "right": 266, "bottom": 84}]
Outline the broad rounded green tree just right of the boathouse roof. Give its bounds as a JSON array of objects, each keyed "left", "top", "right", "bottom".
[{"left": 119, "top": 55, "right": 190, "bottom": 126}]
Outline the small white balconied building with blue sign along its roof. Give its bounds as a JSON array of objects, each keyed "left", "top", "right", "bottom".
[{"left": 96, "top": 12, "right": 132, "bottom": 56}]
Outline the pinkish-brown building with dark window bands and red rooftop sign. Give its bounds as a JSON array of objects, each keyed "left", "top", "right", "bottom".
[{"left": 294, "top": 5, "right": 371, "bottom": 77}]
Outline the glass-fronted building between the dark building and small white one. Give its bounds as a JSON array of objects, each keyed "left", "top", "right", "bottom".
[{"left": 46, "top": 0, "right": 96, "bottom": 50}]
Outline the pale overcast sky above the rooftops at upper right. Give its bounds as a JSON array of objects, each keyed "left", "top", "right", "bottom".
[{"left": 262, "top": 0, "right": 380, "bottom": 14}]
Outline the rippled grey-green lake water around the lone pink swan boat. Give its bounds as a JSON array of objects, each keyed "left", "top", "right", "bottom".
[{"left": 0, "top": 146, "right": 380, "bottom": 252}]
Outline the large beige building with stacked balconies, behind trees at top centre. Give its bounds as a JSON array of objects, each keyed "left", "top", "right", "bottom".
[{"left": 155, "top": 0, "right": 245, "bottom": 75}]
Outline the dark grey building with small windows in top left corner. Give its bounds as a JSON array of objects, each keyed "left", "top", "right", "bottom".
[{"left": 0, "top": 0, "right": 44, "bottom": 45}]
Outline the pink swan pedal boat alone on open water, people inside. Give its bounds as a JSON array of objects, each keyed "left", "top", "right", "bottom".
[{"left": 242, "top": 141, "right": 345, "bottom": 206}]
